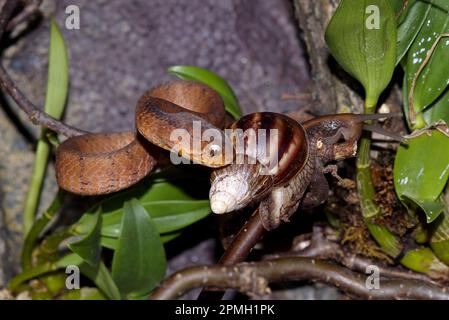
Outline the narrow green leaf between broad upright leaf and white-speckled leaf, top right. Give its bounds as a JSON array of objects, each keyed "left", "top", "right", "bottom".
[{"left": 396, "top": 1, "right": 432, "bottom": 65}]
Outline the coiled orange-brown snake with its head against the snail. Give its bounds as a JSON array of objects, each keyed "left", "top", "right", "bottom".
[{"left": 55, "top": 80, "right": 225, "bottom": 195}]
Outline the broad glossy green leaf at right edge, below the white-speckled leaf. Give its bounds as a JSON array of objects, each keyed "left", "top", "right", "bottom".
[{"left": 393, "top": 130, "right": 449, "bottom": 222}]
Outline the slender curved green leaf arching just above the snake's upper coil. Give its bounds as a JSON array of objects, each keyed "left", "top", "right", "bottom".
[{"left": 168, "top": 66, "right": 242, "bottom": 119}]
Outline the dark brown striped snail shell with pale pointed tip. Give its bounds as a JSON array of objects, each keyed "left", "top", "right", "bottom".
[{"left": 209, "top": 112, "right": 308, "bottom": 214}]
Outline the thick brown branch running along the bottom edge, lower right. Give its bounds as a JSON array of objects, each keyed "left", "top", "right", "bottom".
[{"left": 149, "top": 257, "right": 449, "bottom": 300}]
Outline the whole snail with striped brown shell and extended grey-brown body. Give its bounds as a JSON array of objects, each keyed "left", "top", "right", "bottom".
[{"left": 209, "top": 112, "right": 400, "bottom": 230}]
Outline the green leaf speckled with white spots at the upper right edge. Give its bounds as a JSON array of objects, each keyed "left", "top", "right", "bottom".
[{"left": 406, "top": 6, "right": 449, "bottom": 113}]
